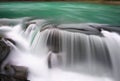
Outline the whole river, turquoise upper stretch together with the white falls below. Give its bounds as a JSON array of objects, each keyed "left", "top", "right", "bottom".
[{"left": 0, "top": 2, "right": 120, "bottom": 81}]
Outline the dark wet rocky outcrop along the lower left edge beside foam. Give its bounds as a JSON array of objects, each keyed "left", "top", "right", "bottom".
[{"left": 0, "top": 38, "right": 28, "bottom": 81}]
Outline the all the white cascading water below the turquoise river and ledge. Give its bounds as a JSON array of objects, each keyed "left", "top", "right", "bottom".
[{"left": 0, "top": 18, "right": 120, "bottom": 81}]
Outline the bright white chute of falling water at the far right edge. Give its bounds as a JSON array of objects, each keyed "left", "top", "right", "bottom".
[{"left": 102, "top": 30, "right": 120, "bottom": 80}]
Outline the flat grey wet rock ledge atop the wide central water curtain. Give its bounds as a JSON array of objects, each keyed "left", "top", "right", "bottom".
[{"left": 40, "top": 23, "right": 101, "bottom": 35}]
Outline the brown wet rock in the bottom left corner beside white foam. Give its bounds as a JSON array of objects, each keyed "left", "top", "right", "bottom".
[{"left": 0, "top": 64, "right": 28, "bottom": 81}]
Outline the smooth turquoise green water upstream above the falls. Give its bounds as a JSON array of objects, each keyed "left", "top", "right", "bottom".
[{"left": 0, "top": 2, "right": 120, "bottom": 25}]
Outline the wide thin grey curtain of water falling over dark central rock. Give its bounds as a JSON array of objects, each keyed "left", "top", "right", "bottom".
[{"left": 44, "top": 28, "right": 112, "bottom": 75}]
